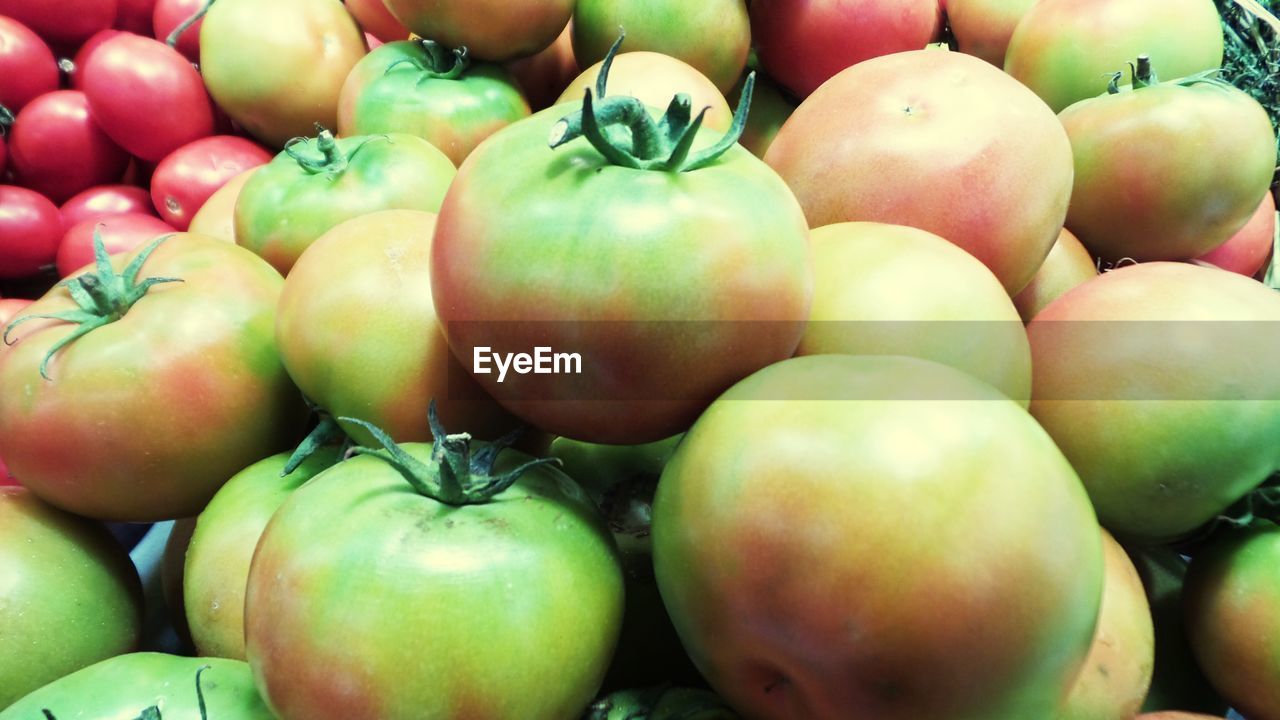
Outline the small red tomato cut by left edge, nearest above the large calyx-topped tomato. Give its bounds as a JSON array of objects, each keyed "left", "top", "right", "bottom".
[{"left": 0, "top": 184, "right": 63, "bottom": 278}]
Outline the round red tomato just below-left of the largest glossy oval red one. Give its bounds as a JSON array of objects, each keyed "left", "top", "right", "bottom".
[{"left": 9, "top": 90, "right": 129, "bottom": 202}]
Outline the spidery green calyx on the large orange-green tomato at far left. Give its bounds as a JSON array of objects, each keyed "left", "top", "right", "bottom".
[{"left": 3, "top": 229, "right": 182, "bottom": 380}]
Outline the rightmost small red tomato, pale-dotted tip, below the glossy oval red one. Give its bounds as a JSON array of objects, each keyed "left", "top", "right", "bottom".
[{"left": 151, "top": 135, "right": 274, "bottom": 231}]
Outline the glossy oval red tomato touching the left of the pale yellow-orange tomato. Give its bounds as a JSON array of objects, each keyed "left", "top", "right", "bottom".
[{"left": 83, "top": 33, "right": 214, "bottom": 161}]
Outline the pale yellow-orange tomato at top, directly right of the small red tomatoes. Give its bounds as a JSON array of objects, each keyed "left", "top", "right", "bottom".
[{"left": 200, "top": 0, "right": 365, "bottom": 147}]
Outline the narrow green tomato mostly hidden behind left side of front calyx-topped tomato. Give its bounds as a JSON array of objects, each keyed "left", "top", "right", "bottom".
[{"left": 182, "top": 447, "right": 338, "bottom": 660}]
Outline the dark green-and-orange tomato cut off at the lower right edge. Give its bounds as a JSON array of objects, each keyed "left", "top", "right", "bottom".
[{"left": 1183, "top": 520, "right": 1280, "bottom": 720}]
